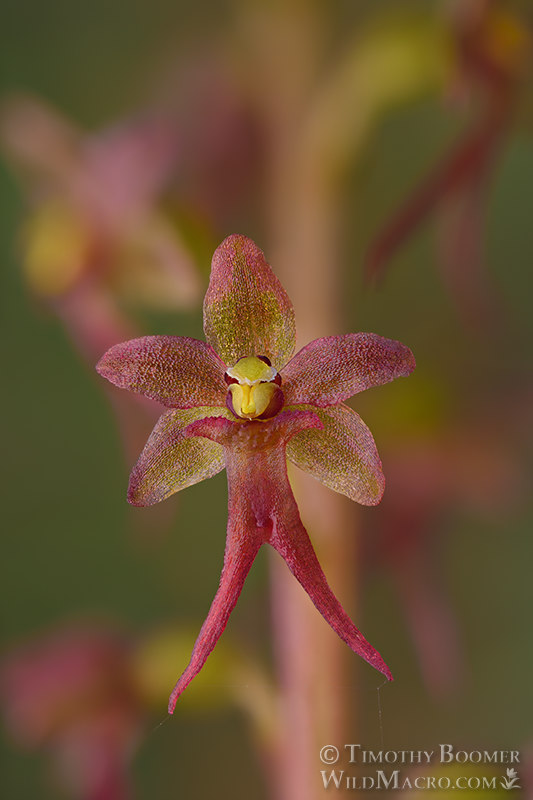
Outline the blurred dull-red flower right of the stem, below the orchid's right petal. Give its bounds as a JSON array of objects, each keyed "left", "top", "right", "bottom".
[{"left": 364, "top": 385, "right": 527, "bottom": 697}]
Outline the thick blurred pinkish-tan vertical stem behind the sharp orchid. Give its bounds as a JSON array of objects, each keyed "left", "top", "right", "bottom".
[{"left": 245, "top": 2, "right": 356, "bottom": 800}]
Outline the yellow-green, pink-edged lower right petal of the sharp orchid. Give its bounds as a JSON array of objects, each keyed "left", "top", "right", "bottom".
[{"left": 287, "top": 405, "right": 385, "bottom": 506}]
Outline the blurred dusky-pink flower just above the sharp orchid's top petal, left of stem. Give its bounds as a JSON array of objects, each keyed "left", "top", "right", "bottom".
[{"left": 159, "top": 54, "right": 266, "bottom": 231}]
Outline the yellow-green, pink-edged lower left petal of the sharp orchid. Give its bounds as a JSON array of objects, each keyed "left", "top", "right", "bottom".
[{"left": 128, "top": 408, "right": 230, "bottom": 506}]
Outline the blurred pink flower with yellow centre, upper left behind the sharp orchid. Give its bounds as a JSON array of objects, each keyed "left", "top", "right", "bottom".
[{"left": 0, "top": 96, "right": 204, "bottom": 462}]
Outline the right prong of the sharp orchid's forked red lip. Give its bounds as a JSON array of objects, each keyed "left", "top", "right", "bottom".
[{"left": 270, "top": 503, "right": 392, "bottom": 681}]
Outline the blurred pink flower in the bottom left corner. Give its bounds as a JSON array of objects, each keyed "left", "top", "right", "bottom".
[{"left": 0, "top": 627, "right": 140, "bottom": 800}]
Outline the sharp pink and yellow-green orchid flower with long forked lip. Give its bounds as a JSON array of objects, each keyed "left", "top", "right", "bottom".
[{"left": 97, "top": 235, "right": 415, "bottom": 713}]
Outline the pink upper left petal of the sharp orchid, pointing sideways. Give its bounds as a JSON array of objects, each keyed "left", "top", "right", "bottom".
[{"left": 96, "top": 336, "right": 227, "bottom": 408}]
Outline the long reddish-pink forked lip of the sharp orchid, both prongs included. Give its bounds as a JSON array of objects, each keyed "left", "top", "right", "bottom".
[{"left": 168, "top": 409, "right": 391, "bottom": 714}]
